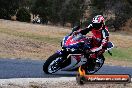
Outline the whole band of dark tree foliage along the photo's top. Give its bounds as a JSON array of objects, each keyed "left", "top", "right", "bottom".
[{"left": 0, "top": 0, "right": 132, "bottom": 30}]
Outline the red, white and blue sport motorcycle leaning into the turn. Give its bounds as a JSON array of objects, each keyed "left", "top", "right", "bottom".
[{"left": 43, "top": 26, "right": 114, "bottom": 74}]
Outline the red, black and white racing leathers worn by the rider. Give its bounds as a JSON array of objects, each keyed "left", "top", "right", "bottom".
[{"left": 79, "top": 24, "right": 109, "bottom": 58}]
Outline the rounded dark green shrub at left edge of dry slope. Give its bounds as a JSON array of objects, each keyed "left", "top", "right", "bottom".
[{"left": 16, "top": 8, "right": 31, "bottom": 22}]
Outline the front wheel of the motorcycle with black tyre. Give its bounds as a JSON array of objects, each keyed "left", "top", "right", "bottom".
[{"left": 43, "top": 53, "right": 62, "bottom": 74}]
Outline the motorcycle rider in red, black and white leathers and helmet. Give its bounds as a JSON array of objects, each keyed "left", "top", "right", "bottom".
[{"left": 75, "top": 15, "right": 109, "bottom": 70}]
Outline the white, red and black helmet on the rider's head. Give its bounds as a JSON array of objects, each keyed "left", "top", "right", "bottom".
[{"left": 92, "top": 15, "right": 105, "bottom": 30}]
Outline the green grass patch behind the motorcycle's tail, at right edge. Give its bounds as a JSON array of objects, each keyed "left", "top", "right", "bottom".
[{"left": 105, "top": 48, "right": 132, "bottom": 61}]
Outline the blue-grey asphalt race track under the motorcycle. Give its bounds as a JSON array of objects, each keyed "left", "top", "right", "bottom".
[{"left": 0, "top": 59, "right": 132, "bottom": 79}]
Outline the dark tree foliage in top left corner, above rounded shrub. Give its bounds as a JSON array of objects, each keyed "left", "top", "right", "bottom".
[{"left": 0, "top": 0, "right": 31, "bottom": 19}]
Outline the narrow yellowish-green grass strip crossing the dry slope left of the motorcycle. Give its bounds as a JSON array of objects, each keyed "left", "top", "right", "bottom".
[{"left": 0, "top": 28, "right": 62, "bottom": 44}]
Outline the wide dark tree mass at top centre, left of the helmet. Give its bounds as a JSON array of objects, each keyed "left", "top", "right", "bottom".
[{"left": 32, "top": 0, "right": 84, "bottom": 26}]
